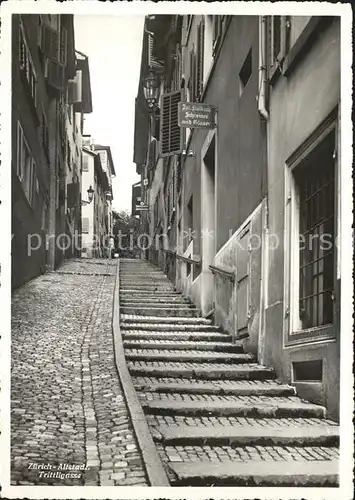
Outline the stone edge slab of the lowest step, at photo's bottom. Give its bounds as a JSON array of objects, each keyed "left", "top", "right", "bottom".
[{"left": 168, "top": 460, "right": 339, "bottom": 486}]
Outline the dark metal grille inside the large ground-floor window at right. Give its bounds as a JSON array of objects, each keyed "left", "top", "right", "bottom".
[{"left": 296, "top": 133, "right": 335, "bottom": 329}]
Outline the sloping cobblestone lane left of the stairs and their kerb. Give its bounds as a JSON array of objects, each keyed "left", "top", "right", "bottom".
[{"left": 11, "top": 260, "right": 147, "bottom": 486}]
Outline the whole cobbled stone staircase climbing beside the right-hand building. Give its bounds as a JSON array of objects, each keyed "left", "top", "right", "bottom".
[{"left": 120, "top": 259, "right": 339, "bottom": 486}]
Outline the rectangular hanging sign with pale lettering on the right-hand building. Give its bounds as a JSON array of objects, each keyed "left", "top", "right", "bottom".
[{"left": 178, "top": 102, "right": 217, "bottom": 129}]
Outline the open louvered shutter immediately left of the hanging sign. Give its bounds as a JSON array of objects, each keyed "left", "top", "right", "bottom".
[{"left": 160, "top": 90, "right": 183, "bottom": 157}]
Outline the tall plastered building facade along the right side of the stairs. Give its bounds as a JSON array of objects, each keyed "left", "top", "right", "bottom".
[{"left": 134, "top": 15, "right": 341, "bottom": 417}]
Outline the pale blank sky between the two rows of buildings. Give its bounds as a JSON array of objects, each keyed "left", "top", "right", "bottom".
[{"left": 74, "top": 15, "right": 144, "bottom": 212}]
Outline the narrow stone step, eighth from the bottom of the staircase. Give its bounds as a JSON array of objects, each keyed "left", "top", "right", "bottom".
[{"left": 121, "top": 332, "right": 232, "bottom": 344}]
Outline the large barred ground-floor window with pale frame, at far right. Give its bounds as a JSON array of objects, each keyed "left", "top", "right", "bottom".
[{"left": 285, "top": 114, "right": 338, "bottom": 343}]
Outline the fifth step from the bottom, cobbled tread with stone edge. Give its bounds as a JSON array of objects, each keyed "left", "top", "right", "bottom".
[{"left": 127, "top": 361, "right": 275, "bottom": 380}]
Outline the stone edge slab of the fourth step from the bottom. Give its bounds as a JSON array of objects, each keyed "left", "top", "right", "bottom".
[{"left": 135, "top": 380, "right": 296, "bottom": 396}]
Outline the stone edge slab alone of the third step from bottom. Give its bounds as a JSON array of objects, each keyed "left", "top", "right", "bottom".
[{"left": 142, "top": 400, "right": 326, "bottom": 418}]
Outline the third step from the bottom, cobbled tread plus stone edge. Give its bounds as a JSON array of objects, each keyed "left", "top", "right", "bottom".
[{"left": 140, "top": 393, "right": 325, "bottom": 418}]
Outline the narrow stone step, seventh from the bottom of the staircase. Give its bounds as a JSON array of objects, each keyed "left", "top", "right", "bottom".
[{"left": 123, "top": 336, "right": 244, "bottom": 353}]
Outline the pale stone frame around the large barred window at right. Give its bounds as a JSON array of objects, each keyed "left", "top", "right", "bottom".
[{"left": 284, "top": 112, "right": 340, "bottom": 347}]
